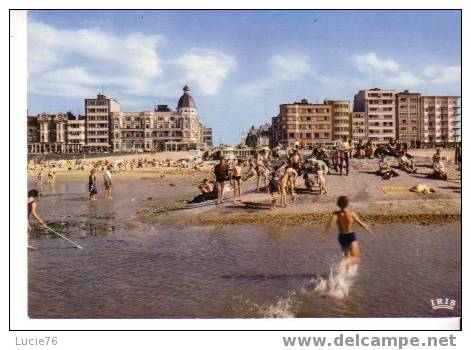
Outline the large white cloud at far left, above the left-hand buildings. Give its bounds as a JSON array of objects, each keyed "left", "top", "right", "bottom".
[{"left": 28, "top": 21, "right": 162, "bottom": 98}]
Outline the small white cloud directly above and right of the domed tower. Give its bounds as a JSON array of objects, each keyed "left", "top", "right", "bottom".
[{"left": 175, "top": 49, "right": 236, "bottom": 95}]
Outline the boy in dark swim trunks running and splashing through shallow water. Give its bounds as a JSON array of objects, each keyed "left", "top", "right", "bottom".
[{"left": 321, "top": 196, "right": 373, "bottom": 269}]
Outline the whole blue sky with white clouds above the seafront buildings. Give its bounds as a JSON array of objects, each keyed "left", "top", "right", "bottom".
[{"left": 28, "top": 10, "right": 461, "bottom": 144}]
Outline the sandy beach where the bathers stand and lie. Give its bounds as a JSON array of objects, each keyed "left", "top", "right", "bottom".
[{"left": 29, "top": 149, "right": 461, "bottom": 225}]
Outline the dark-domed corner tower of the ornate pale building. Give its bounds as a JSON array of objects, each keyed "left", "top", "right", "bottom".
[{"left": 177, "top": 85, "right": 202, "bottom": 143}]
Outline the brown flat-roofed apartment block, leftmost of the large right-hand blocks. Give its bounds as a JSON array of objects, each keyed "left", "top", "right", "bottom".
[{"left": 271, "top": 99, "right": 332, "bottom": 147}]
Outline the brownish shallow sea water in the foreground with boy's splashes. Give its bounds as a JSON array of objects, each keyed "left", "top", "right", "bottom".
[{"left": 28, "top": 180, "right": 461, "bottom": 318}]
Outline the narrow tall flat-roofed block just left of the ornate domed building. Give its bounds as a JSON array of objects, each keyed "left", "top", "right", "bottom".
[{"left": 85, "top": 94, "right": 120, "bottom": 152}]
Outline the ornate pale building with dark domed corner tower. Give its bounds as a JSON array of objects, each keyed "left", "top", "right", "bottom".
[{"left": 111, "top": 86, "right": 212, "bottom": 152}]
